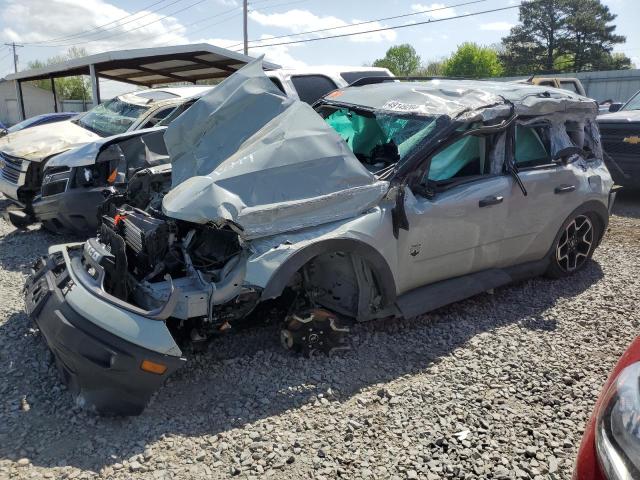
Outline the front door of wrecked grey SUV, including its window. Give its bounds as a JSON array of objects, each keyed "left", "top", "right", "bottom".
[{"left": 398, "top": 130, "right": 512, "bottom": 293}]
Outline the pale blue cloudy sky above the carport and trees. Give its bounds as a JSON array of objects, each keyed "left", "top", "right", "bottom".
[{"left": 0, "top": 0, "right": 640, "bottom": 98}]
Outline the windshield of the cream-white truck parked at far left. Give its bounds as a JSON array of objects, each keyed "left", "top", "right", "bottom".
[{"left": 75, "top": 98, "right": 149, "bottom": 137}]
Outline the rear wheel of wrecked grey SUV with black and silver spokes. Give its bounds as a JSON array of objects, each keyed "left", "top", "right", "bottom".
[{"left": 545, "top": 212, "right": 602, "bottom": 278}]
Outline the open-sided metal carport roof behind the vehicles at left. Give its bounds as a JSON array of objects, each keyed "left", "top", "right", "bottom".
[{"left": 6, "top": 43, "right": 279, "bottom": 87}]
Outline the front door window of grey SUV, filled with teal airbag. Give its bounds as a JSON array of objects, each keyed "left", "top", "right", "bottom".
[{"left": 427, "top": 135, "right": 492, "bottom": 183}]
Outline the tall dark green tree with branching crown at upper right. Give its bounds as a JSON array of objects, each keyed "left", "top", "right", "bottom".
[{"left": 500, "top": 0, "right": 625, "bottom": 75}]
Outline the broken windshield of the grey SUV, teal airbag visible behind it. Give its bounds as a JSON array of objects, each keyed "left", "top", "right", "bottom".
[{"left": 318, "top": 105, "right": 436, "bottom": 172}]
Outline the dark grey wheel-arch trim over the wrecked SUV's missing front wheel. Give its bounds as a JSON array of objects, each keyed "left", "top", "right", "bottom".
[{"left": 262, "top": 238, "right": 397, "bottom": 306}]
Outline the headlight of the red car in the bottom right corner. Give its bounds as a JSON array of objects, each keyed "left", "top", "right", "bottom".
[{"left": 595, "top": 362, "right": 640, "bottom": 480}]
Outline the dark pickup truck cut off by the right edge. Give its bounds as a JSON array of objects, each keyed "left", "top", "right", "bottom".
[{"left": 598, "top": 92, "right": 640, "bottom": 189}]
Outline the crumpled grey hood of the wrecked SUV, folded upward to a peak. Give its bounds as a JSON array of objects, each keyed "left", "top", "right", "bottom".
[{"left": 162, "top": 59, "right": 388, "bottom": 239}]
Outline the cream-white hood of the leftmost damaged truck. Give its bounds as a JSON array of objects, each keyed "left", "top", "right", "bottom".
[{"left": 0, "top": 120, "right": 101, "bottom": 162}]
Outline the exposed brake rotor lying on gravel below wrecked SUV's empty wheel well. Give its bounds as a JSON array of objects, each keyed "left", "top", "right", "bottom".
[{"left": 280, "top": 308, "right": 349, "bottom": 357}]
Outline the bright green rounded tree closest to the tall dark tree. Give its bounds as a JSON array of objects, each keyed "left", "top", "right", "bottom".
[{"left": 443, "top": 42, "right": 503, "bottom": 78}]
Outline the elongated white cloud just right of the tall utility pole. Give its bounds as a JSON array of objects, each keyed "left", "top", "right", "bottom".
[{"left": 249, "top": 9, "right": 397, "bottom": 42}]
